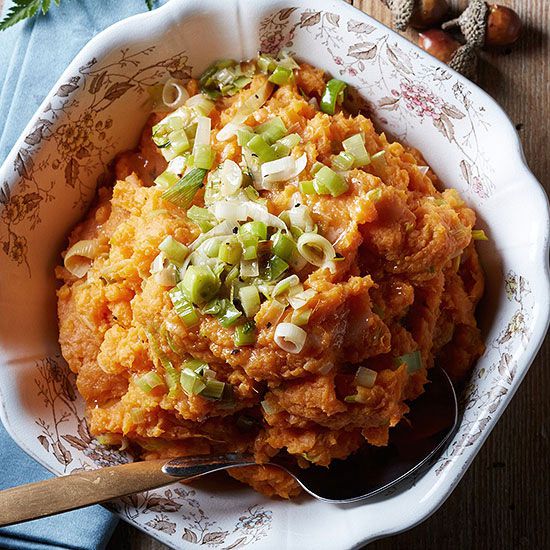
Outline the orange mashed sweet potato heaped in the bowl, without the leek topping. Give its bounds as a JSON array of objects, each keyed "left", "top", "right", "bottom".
[{"left": 57, "top": 65, "right": 484, "bottom": 498}]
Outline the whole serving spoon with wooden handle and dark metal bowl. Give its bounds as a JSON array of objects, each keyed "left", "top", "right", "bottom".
[{"left": 0, "top": 368, "right": 458, "bottom": 527}]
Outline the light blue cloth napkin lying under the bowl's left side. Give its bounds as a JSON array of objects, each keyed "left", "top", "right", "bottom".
[{"left": 0, "top": 0, "right": 164, "bottom": 550}]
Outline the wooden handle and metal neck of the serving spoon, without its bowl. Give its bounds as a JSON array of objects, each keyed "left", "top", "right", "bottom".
[{"left": 0, "top": 455, "right": 250, "bottom": 527}]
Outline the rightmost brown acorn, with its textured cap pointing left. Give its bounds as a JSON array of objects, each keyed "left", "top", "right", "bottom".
[{"left": 441, "top": 0, "right": 522, "bottom": 48}]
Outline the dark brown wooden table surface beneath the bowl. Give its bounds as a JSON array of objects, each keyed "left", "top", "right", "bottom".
[{"left": 108, "top": 0, "right": 550, "bottom": 550}]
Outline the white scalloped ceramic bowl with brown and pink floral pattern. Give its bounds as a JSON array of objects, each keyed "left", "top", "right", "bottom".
[{"left": 0, "top": 0, "right": 549, "bottom": 550}]
